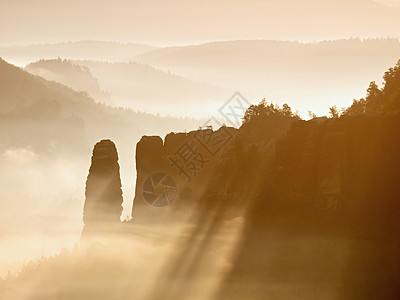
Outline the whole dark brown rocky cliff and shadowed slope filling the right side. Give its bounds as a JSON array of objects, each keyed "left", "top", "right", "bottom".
[{"left": 132, "top": 112, "right": 400, "bottom": 299}]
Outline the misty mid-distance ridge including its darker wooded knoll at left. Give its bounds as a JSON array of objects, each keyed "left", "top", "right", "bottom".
[{"left": 25, "top": 59, "right": 233, "bottom": 117}]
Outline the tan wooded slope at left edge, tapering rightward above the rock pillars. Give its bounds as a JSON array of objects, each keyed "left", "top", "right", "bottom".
[{"left": 0, "top": 60, "right": 203, "bottom": 152}]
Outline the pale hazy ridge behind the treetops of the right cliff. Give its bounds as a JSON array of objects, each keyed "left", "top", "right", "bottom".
[{"left": 134, "top": 39, "right": 400, "bottom": 114}]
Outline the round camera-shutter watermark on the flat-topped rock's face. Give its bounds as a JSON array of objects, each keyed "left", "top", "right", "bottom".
[{"left": 142, "top": 173, "right": 177, "bottom": 207}]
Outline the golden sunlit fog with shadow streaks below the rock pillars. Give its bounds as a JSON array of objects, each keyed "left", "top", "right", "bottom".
[{"left": 0, "top": 213, "right": 243, "bottom": 299}]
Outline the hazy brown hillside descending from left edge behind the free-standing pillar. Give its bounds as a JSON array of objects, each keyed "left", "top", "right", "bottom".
[{"left": 0, "top": 60, "right": 201, "bottom": 154}]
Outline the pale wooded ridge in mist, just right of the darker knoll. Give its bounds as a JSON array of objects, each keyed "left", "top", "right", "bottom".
[{"left": 73, "top": 61, "right": 230, "bottom": 117}]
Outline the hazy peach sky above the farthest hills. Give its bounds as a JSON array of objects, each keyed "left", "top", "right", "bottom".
[{"left": 0, "top": 0, "right": 400, "bottom": 45}]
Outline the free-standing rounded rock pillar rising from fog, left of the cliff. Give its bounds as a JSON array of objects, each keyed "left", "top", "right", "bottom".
[{"left": 82, "top": 140, "right": 123, "bottom": 237}]
